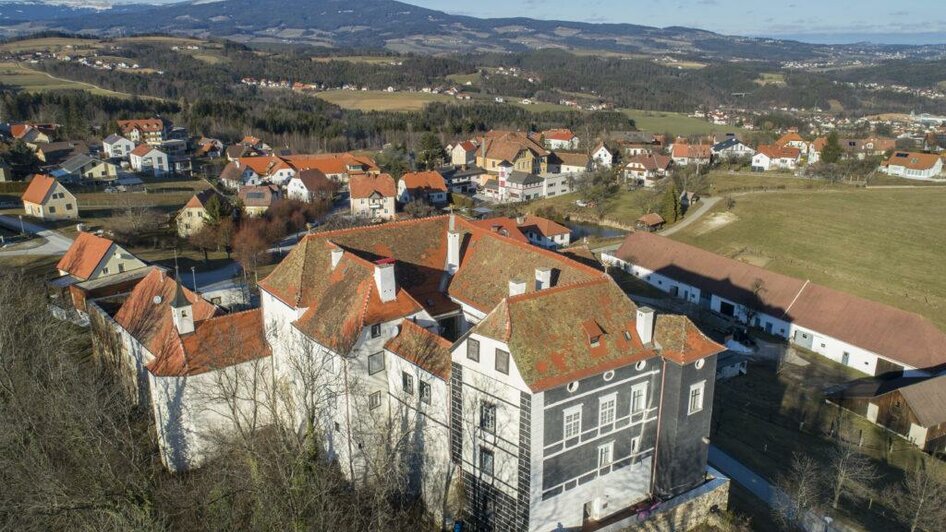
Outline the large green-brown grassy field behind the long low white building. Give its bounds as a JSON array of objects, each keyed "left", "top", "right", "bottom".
[{"left": 674, "top": 188, "right": 946, "bottom": 329}]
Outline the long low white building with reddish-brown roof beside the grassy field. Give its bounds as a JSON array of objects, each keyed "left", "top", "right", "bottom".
[{"left": 602, "top": 232, "right": 946, "bottom": 376}]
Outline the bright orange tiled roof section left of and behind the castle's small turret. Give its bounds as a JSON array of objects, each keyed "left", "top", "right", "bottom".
[{"left": 115, "top": 268, "right": 218, "bottom": 369}]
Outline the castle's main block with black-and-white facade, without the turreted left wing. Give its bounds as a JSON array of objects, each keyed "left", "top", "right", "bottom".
[{"left": 253, "top": 216, "right": 723, "bottom": 530}]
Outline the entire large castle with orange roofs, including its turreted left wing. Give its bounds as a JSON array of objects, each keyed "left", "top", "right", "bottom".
[{"left": 90, "top": 214, "right": 723, "bottom": 531}]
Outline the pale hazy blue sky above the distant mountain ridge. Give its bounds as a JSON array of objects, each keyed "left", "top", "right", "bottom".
[{"left": 404, "top": 0, "right": 946, "bottom": 42}]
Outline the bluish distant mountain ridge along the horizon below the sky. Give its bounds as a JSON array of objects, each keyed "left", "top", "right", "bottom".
[{"left": 0, "top": 0, "right": 940, "bottom": 61}]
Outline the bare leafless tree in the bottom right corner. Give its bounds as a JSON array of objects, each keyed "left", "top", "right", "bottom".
[{"left": 890, "top": 463, "right": 946, "bottom": 532}]
